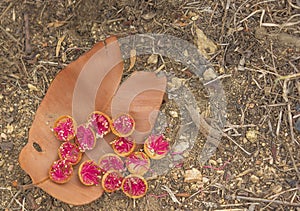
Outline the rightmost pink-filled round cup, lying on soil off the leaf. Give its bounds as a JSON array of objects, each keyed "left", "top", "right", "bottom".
[{"left": 144, "top": 135, "right": 170, "bottom": 159}]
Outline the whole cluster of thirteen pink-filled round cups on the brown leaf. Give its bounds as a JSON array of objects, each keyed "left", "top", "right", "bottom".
[{"left": 49, "top": 111, "right": 170, "bottom": 198}]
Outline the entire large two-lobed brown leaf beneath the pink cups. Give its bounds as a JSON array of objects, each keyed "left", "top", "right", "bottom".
[{"left": 19, "top": 37, "right": 166, "bottom": 205}]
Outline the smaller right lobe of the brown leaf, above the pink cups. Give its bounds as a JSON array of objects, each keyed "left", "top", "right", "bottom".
[{"left": 111, "top": 71, "right": 167, "bottom": 144}]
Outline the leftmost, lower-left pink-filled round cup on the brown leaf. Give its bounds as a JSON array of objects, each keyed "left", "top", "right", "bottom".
[{"left": 49, "top": 160, "right": 73, "bottom": 184}]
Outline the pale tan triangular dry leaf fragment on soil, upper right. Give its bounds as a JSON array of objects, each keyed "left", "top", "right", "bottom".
[{"left": 195, "top": 27, "right": 218, "bottom": 59}]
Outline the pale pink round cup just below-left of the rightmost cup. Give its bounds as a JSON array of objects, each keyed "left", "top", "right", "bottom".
[{"left": 126, "top": 152, "right": 150, "bottom": 175}]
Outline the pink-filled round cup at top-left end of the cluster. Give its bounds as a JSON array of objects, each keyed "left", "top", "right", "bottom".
[{"left": 53, "top": 116, "right": 76, "bottom": 141}]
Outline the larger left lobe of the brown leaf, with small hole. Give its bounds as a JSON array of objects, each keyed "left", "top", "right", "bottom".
[{"left": 19, "top": 37, "right": 123, "bottom": 205}]
